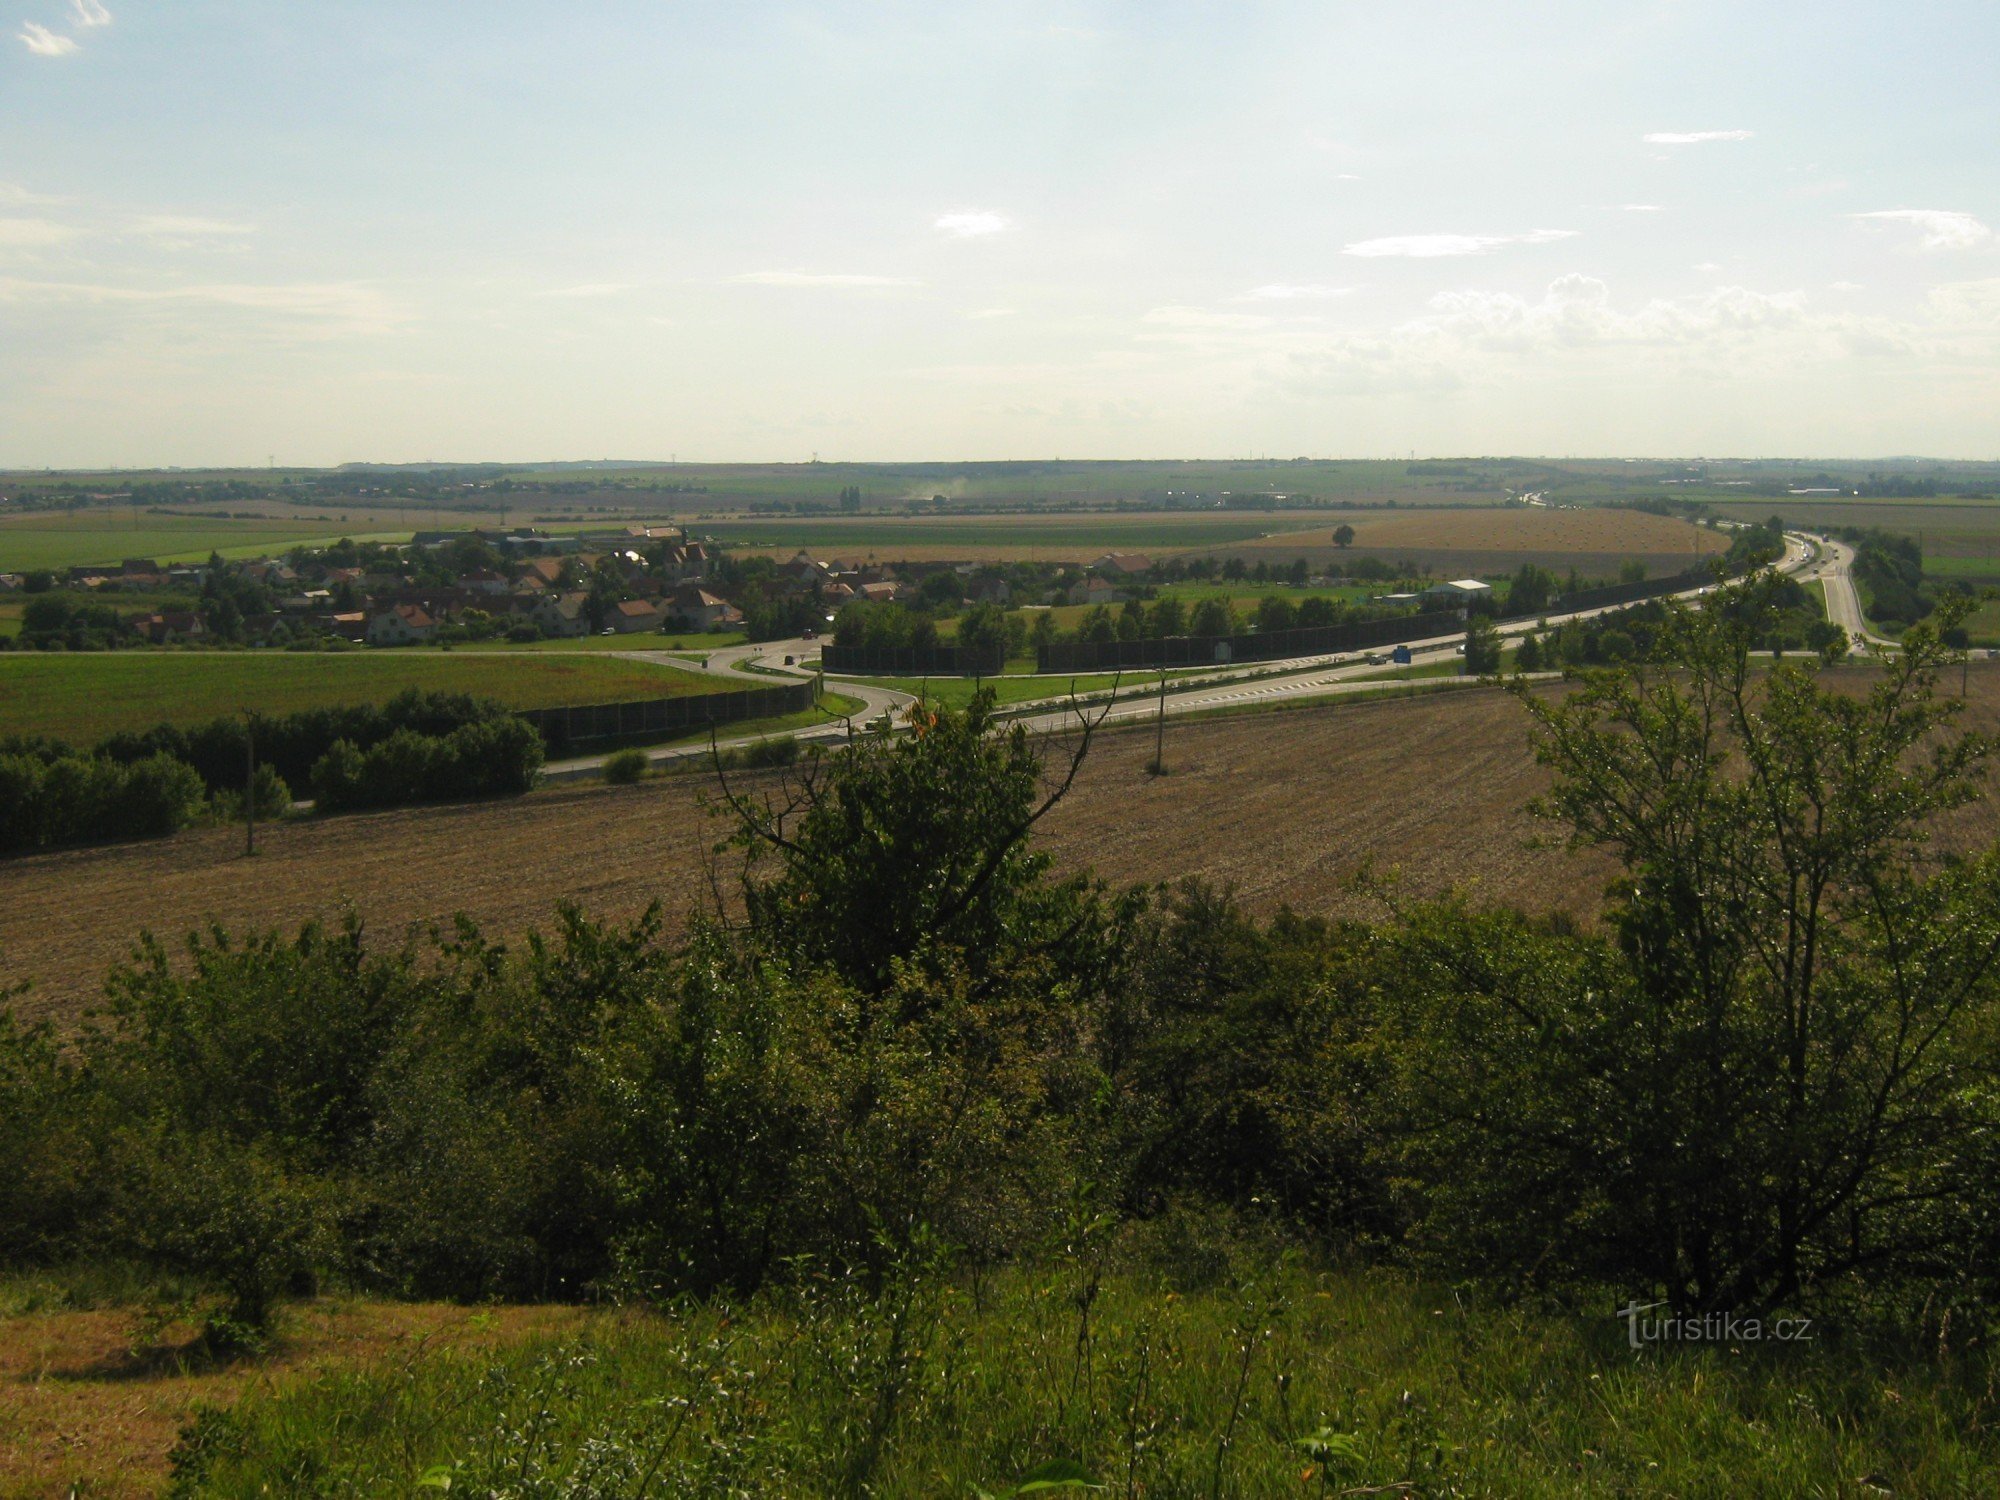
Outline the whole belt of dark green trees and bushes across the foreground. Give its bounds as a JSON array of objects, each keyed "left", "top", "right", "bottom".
[{"left": 0, "top": 590, "right": 2000, "bottom": 1322}]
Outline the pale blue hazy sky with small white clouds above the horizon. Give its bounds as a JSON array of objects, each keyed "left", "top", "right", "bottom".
[{"left": 0, "top": 0, "right": 2000, "bottom": 468}]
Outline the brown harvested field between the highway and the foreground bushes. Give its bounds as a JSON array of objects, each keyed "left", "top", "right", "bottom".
[{"left": 11, "top": 666, "right": 2000, "bottom": 1020}]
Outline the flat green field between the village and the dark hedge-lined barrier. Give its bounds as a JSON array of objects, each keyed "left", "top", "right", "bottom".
[{"left": 0, "top": 652, "right": 756, "bottom": 744}]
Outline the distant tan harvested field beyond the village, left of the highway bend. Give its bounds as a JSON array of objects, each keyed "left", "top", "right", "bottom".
[{"left": 1208, "top": 506, "right": 1728, "bottom": 578}]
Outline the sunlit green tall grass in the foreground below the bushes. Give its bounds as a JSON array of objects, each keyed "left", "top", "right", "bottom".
[{"left": 178, "top": 1254, "right": 2000, "bottom": 1500}]
